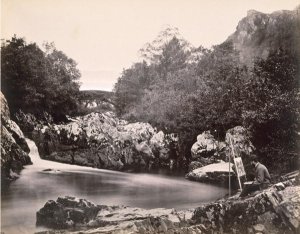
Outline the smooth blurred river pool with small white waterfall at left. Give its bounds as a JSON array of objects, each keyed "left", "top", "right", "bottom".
[{"left": 1, "top": 140, "right": 227, "bottom": 234}]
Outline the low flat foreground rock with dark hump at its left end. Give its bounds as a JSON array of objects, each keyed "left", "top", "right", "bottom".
[{"left": 37, "top": 197, "right": 193, "bottom": 233}]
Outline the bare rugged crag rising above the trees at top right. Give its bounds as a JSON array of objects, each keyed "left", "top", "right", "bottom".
[{"left": 227, "top": 7, "right": 300, "bottom": 65}]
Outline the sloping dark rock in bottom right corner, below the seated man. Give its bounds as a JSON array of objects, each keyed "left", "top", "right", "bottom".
[{"left": 192, "top": 186, "right": 300, "bottom": 234}]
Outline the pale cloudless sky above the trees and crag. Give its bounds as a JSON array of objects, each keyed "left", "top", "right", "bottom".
[{"left": 0, "top": 0, "right": 300, "bottom": 90}]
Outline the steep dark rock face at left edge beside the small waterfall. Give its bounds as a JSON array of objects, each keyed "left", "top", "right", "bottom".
[{"left": 0, "top": 92, "right": 31, "bottom": 185}]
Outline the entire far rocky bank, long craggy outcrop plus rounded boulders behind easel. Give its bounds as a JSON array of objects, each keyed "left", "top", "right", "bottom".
[{"left": 16, "top": 105, "right": 254, "bottom": 180}]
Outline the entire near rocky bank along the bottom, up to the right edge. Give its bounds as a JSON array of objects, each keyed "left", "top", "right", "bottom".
[{"left": 37, "top": 177, "right": 300, "bottom": 234}]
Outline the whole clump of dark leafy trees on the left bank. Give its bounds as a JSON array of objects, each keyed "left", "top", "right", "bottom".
[{"left": 1, "top": 36, "right": 80, "bottom": 118}]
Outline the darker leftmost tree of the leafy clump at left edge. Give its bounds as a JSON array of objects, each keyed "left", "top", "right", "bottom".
[{"left": 1, "top": 37, "right": 47, "bottom": 112}]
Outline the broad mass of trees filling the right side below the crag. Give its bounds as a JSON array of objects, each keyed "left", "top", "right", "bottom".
[{"left": 115, "top": 28, "right": 299, "bottom": 171}]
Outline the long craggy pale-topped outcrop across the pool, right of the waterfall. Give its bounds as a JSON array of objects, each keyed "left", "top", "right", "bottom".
[{"left": 18, "top": 112, "right": 177, "bottom": 171}]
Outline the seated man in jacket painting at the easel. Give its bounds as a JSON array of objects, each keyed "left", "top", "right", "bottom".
[{"left": 240, "top": 157, "right": 271, "bottom": 197}]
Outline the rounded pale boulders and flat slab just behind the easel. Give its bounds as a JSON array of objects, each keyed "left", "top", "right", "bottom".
[{"left": 186, "top": 126, "right": 255, "bottom": 179}]
